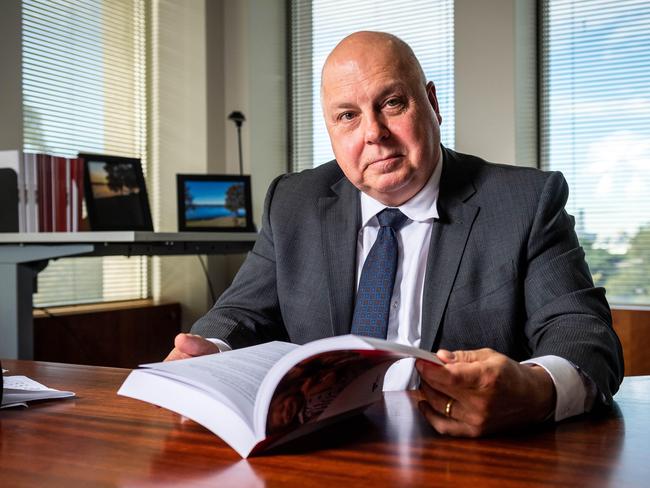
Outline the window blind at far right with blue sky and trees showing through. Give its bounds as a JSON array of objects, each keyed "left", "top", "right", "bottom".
[{"left": 541, "top": 0, "right": 650, "bottom": 306}]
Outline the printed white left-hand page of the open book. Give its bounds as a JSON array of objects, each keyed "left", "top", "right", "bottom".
[{"left": 143, "top": 341, "right": 298, "bottom": 426}]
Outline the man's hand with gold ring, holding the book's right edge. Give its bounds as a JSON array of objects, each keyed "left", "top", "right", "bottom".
[{"left": 416, "top": 349, "right": 555, "bottom": 437}]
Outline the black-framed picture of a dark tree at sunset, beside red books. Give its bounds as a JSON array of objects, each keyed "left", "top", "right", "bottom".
[{"left": 79, "top": 154, "right": 153, "bottom": 231}]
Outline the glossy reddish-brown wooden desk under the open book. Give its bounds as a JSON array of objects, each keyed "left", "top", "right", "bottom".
[{"left": 0, "top": 361, "right": 650, "bottom": 488}]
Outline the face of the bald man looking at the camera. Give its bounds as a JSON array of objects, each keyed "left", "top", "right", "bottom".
[{"left": 322, "top": 43, "right": 440, "bottom": 206}]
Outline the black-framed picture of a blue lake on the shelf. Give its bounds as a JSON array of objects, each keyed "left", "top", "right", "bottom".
[{"left": 176, "top": 175, "right": 255, "bottom": 232}]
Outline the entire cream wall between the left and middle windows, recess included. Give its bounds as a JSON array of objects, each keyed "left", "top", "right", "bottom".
[{"left": 151, "top": 0, "right": 287, "bottom": 329}]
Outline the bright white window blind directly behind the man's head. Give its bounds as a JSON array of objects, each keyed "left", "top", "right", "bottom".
[{"left": 290, "top": 0, "right": 454, "bottom": 171}]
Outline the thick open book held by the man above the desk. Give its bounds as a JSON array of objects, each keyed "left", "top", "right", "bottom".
[{"left": 118, "top": 335, "right": 442, "bottom": 457}]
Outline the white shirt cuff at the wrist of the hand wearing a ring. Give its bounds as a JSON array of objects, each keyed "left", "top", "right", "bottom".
[{"left": 521, "top": 356, "right": 595, "bottom": 422}]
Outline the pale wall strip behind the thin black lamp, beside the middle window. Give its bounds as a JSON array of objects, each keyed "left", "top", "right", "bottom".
[{"left": 224, "top": 0, "right": 287, "bottom": 227}]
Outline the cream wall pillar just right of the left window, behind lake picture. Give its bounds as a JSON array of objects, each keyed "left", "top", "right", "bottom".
[{"left": 149, "top": 0, "right": 210, "bottom": 328}]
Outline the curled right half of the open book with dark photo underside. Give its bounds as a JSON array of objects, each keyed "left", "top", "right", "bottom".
[{"left": 254, "top": 335, "right": 442, "bottom": 436}]
